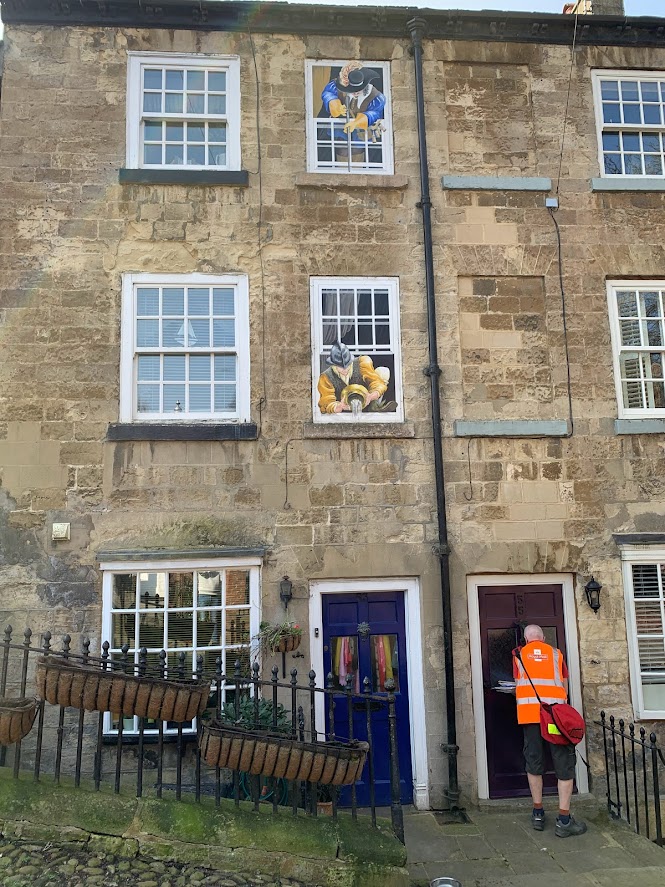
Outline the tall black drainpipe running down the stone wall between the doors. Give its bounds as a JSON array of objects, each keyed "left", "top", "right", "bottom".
[{"left": 407, "top": 18, "right": 459, "bottom": 812}]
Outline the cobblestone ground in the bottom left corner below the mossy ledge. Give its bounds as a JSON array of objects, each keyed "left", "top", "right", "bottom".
[{"left": 0, "top": 838, "right": 307, "bottom": 887}]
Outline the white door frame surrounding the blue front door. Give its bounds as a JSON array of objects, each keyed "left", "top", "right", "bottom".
[{"left": 309, "top": 578, "right": 429, "bottom": 810}]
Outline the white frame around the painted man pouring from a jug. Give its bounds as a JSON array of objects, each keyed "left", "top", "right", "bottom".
[{"left": 310, "top": 277, "right": 404, "bottom": 425}]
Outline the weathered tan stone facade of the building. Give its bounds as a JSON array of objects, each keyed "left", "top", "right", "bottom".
[{"left": 0, "top": 2, "right": 665, "bottom": 807}]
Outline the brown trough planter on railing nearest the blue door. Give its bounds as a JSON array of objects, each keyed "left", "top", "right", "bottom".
[{"left": 201, "top": 722, "right": 369, "bottom": 785}]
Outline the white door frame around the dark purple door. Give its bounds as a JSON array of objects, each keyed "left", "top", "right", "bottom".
[{"left": 467, "top": 573, "right": 589, "bottom": 799}]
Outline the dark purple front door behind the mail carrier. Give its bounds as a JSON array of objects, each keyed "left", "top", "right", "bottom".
[{"left": 478, "top": 584, "right": 566, "bottom": 798}]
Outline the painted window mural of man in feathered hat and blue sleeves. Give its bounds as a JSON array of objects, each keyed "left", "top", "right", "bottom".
[{"left": 307, "top": 60, "right": 393, "bottom": 173}]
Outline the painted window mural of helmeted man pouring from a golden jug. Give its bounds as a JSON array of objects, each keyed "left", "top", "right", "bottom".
[{"left": 311, "top": 277, "right": 404, "bottom": 422}]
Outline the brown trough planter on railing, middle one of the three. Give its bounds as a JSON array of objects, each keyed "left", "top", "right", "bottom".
[{"left": 36, "top": 656, "right": 210, "bottom": 723}]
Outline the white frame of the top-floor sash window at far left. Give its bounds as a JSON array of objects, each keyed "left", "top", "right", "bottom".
[{"left": 127, "top": 52, "right": 241, "bottom": 172}]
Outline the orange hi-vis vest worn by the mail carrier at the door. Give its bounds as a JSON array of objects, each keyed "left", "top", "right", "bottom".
[{"left": 514, "top": 641, "right": 566, "bottom": 724}]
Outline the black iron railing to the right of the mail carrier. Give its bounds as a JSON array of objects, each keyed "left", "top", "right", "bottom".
[{"left": 594, "top": 711, "right": 665, "bottom": 847}]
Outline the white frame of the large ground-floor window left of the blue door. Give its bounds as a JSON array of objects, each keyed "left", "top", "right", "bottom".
[{"left": 100, "top": 557, "right": 262, "bottom": 737}]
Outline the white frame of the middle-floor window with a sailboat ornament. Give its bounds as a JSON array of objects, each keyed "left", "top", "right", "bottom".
[{"left": 120, "top": 273, "right": 250, "bottom": 423}]
